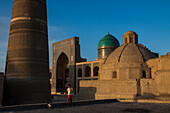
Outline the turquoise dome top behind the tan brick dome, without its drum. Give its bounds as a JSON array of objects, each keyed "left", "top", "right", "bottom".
[{"left": 98, "top": 34, "right": 120, "bottom": 48}]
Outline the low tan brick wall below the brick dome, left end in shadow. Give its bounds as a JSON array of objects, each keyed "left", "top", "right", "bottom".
[{"left": 79, "top": 79, "right": 137, "bottom": 100}]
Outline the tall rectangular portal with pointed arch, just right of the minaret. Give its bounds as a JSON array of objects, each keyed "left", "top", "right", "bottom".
[{"left": 51, "top": 37, "right": 86, "bottom": 94}]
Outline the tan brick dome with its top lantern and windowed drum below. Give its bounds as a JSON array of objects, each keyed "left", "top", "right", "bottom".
[{"left": 100, "top": 31, "right": 158, "bottom": 80}]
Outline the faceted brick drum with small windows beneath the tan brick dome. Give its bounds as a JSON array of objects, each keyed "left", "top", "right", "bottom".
[{"left": 100, "top": 66, "right": 152, "bottom": 80}]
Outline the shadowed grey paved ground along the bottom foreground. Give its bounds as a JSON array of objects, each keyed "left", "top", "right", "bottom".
[{"left": 3, "top": 102, "right": 170, "bottom": 113}]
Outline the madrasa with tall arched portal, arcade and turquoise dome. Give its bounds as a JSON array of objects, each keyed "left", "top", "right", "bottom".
[{"left": 50, "top": 33, "right": 120, "bottom": 94}]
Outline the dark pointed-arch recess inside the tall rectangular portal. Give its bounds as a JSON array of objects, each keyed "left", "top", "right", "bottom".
[{"left": 56, "top": 52, "right": 69, "bottom": 92}]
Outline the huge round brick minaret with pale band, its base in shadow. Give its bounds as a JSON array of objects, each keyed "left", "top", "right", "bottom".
[{"left": 3, "top": 0, "right": 51, "bottom": 105}]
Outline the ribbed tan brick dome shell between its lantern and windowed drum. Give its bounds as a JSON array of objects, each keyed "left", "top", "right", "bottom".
[{"left": 105, "top": 43, "right": 158, "bottom": 65}]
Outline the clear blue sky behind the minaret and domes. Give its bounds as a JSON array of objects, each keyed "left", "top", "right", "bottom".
[{"left": 0, "top": 0, "right": 170, "bottom": 71}]
